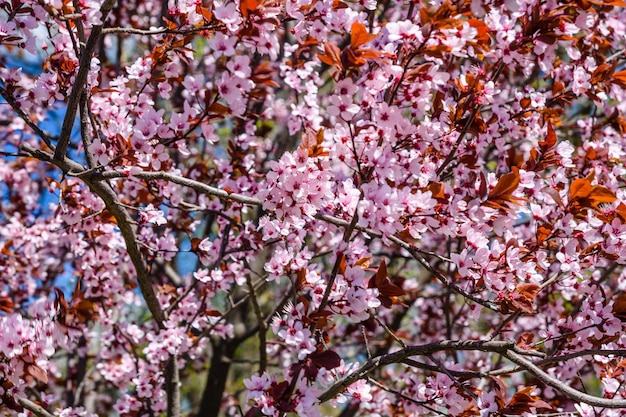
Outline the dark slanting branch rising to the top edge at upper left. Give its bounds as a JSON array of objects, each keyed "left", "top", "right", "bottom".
[{"left": 54, "top": 0, "right": 115, "bottom": 160}]
